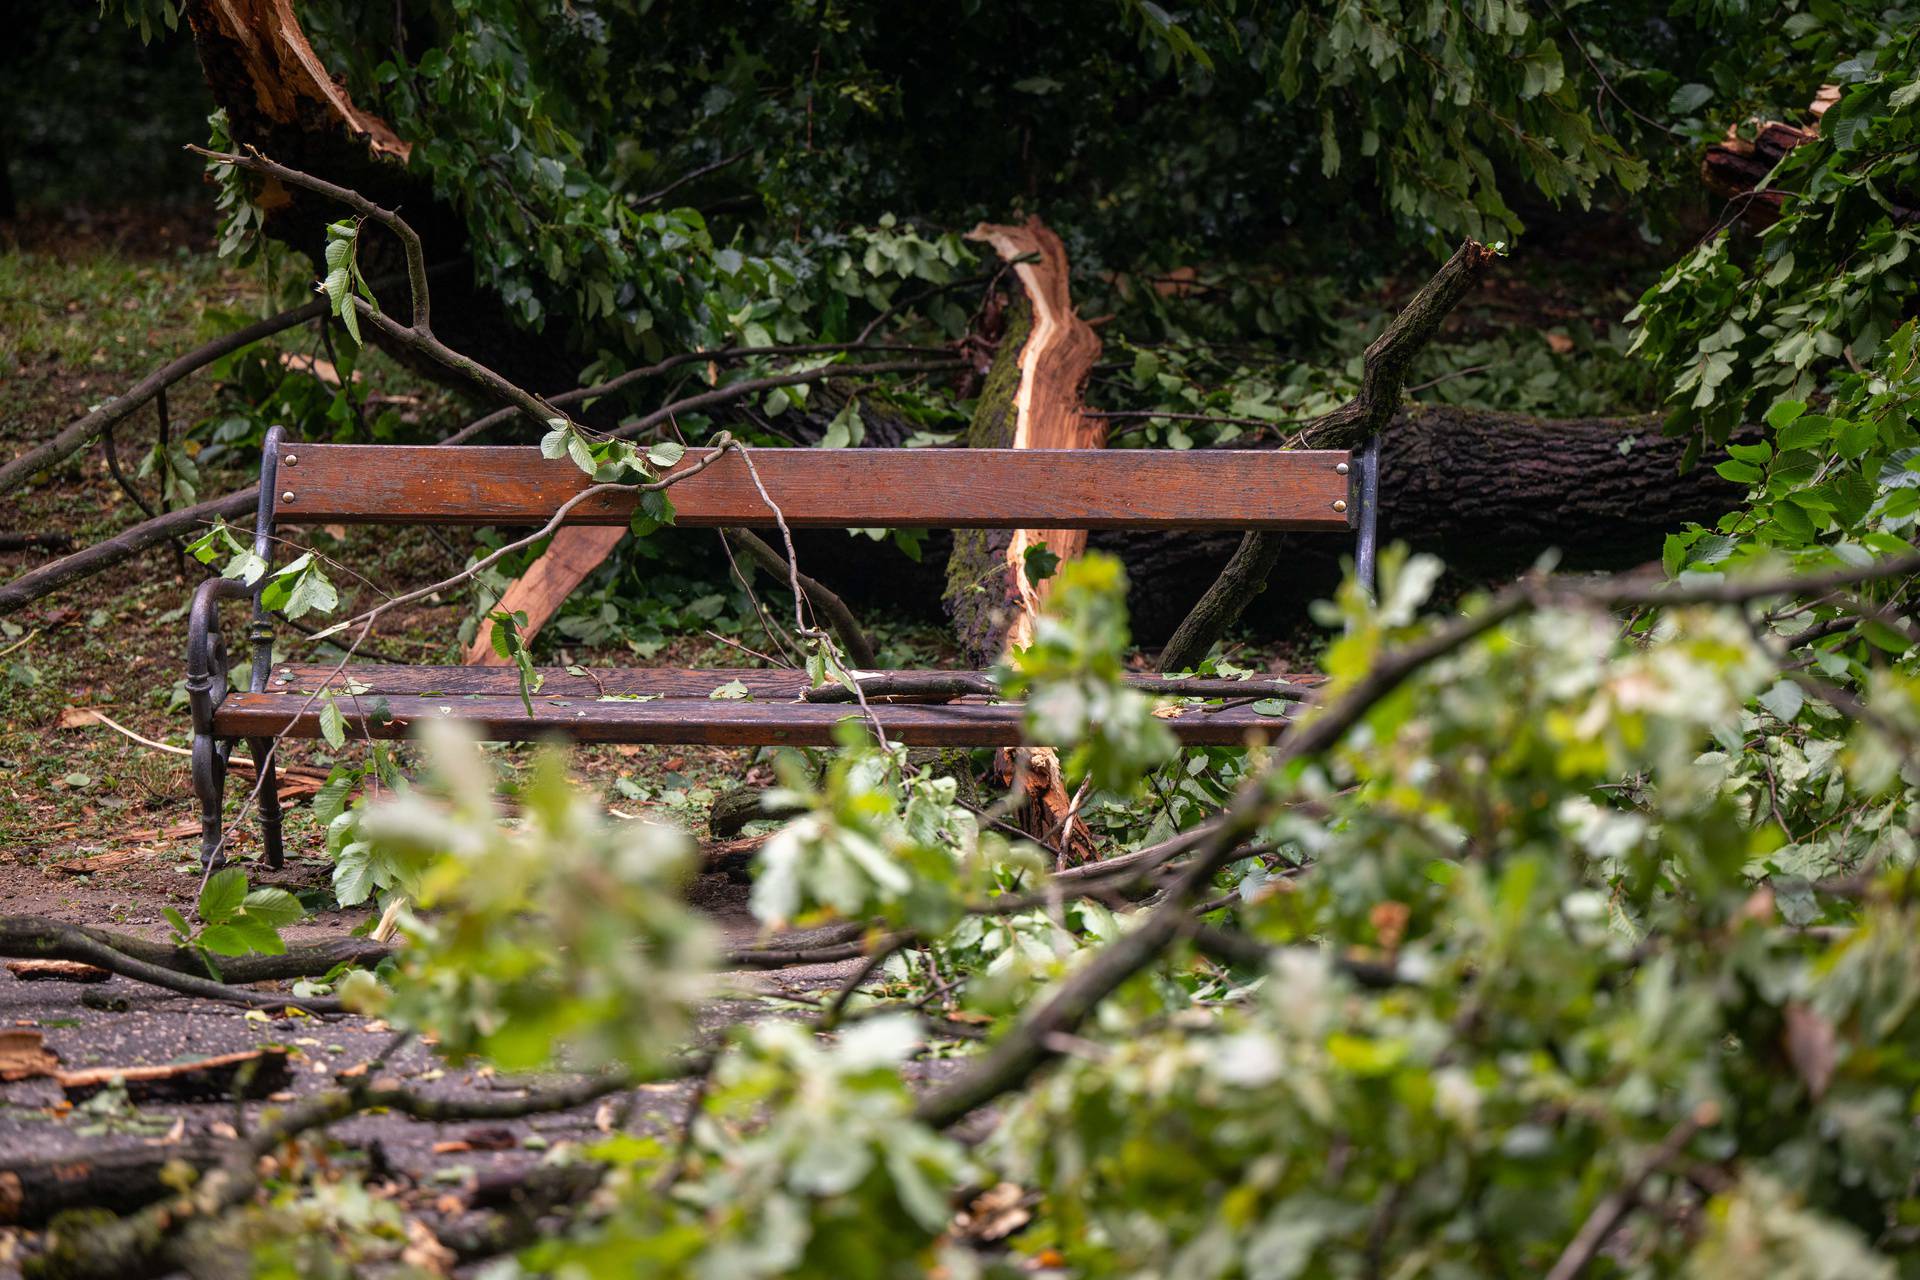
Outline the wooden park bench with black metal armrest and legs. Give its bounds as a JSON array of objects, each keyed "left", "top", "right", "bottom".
[{"left": 186, "top": 428, "right": 1375, "bottom": 867}]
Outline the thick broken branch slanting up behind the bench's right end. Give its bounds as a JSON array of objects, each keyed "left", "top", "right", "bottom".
[{"left": 1160, "top": 240, "right": 1494, "bottom": 672}]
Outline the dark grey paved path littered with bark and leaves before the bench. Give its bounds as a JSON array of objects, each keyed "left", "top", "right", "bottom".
[{"left": 0, "top": 871, "right": 952, "bottom": 1274}]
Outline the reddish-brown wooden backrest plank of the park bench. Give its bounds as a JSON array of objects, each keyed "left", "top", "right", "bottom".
[{"left": 275, "top": 443, "right": 1350, "bottom": 532}]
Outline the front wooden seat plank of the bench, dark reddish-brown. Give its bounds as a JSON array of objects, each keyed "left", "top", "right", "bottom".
[{"left": 213, "top": 693, "right": 1292, "bottom": 747}]
